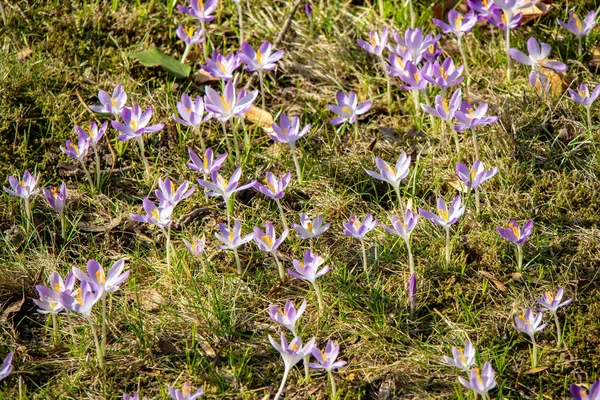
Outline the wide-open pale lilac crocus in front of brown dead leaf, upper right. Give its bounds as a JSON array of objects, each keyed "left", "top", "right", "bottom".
[{"left": 509, "top": 36, "right": 567, "bottom": 89}]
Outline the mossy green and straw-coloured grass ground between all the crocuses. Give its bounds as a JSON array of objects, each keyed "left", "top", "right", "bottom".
[{"left": 0, "top": 0, "right": 600, "bottom": 399}]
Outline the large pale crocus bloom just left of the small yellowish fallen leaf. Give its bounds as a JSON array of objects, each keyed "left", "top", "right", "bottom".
[{"left": 204, "top": 81, "right": 258, "bottom": 122}]
